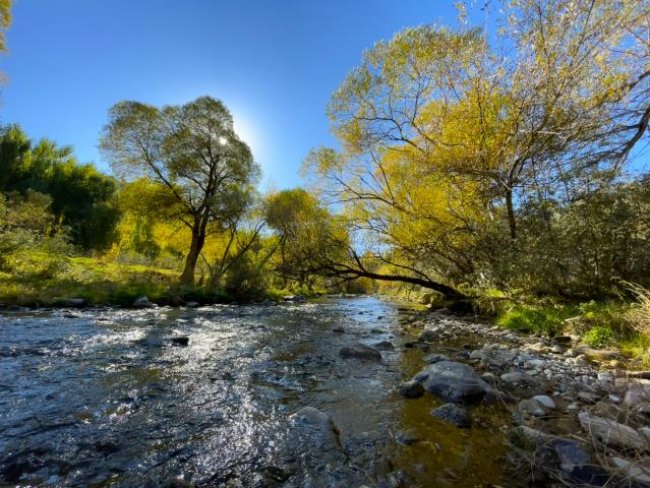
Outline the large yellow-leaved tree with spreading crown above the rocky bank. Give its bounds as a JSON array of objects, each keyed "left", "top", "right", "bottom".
[{"left": 306, "top": 0, "right": 650, "bottom": 298}]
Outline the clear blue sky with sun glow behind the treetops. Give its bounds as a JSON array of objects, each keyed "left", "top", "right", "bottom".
[{"left": 0, "top": 0, "right": 456, "bottom": 188}]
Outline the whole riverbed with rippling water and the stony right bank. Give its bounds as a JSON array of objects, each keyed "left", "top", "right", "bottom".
[{"left": 0, "top": 298, "right": 650, "bottom": 487}]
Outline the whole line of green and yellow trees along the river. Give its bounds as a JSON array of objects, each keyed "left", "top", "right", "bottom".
[{"left": 0, "top": 0, "right": 650, "bottom": 310}]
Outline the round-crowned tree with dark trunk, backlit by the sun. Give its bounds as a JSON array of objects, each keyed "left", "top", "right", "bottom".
[{"left": 101, "top": 97, "right": 259, "bottom": 285}]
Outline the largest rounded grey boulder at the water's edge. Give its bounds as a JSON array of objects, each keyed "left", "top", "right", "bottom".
[{"left": 415, "top": 361, "right": 490, "bottom": 403}]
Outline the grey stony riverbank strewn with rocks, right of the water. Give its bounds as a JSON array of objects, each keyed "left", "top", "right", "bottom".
[{"left": 402, "top": 313, "right": 650, "bottom": 486}]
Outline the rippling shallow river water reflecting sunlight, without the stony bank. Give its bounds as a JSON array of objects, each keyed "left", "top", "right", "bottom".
[{"left": 0, "top": 298, "right": 515, "bottom": 487}]
